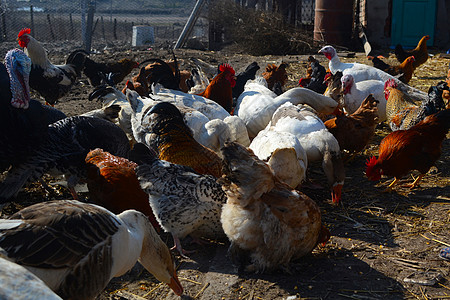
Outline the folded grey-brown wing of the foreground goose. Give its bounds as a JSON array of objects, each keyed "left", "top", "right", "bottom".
[{"left": 0, "top": 201, "right": 121, "bottom": 268}]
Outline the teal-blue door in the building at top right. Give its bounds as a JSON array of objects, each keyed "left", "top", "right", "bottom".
[{"left": 391, "top": 0, "right": 437, "bottom": 48}]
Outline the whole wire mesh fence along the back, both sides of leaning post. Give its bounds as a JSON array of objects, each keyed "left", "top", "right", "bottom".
[{"left": 0, "top": 0, "right": 315, "bottom": 48}]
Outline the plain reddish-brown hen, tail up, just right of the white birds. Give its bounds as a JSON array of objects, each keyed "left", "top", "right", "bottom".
[{"left": 324, "top": 94, "right": 378, "bottom": 153}]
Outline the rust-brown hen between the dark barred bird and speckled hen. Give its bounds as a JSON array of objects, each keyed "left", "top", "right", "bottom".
[{"left": 86, "top": 148, "right": 160, "bottom": 229}]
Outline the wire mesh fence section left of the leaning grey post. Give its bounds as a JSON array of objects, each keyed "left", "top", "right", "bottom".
[{"left": 0, "top": 0, "right": 197, "bottom": 45}]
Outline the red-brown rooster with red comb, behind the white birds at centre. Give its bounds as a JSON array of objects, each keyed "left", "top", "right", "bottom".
[{"left": 198, "top": 64, "right": 236, "bottom": 112}]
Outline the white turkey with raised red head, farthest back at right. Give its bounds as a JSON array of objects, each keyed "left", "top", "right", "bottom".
[{"left": 319, "top": 45, "right": 427, "bottom": 100}]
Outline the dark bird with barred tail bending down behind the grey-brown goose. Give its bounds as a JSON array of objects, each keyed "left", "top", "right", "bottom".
[{"left": 0, "top": 116, "right": 130, "bottom": 203}]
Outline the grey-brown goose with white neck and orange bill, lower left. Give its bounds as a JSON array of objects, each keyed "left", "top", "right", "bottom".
[{"left": 0, "top": 200, "right": 183, "bottom": 299}]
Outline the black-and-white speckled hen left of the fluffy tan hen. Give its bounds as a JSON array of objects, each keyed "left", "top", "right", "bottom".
[{"left": 129, "top": 143, "right": 226, "bottom": 256}]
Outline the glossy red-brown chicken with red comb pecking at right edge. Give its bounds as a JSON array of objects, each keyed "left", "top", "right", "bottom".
[{"left": 366, "top": 109, "right": 450, "bottom": 188}]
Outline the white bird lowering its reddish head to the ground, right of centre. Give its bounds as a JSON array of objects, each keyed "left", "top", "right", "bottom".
[{"left": 271, "top": 102, "right": 345, "bottom": 203}]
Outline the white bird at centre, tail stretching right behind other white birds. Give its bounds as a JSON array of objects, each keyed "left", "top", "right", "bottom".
[{"left": 235, "top": 78, "right": 337, "bottom": 138}]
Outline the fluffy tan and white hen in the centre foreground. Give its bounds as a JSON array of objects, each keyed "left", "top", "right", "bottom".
[{"left": 219, "top": 143, "right": 330, "bottom": 272}]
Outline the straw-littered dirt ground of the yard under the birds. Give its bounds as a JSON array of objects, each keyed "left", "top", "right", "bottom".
[{"left": 0, "top": 43, "right": 450, "bottom": 300}]
